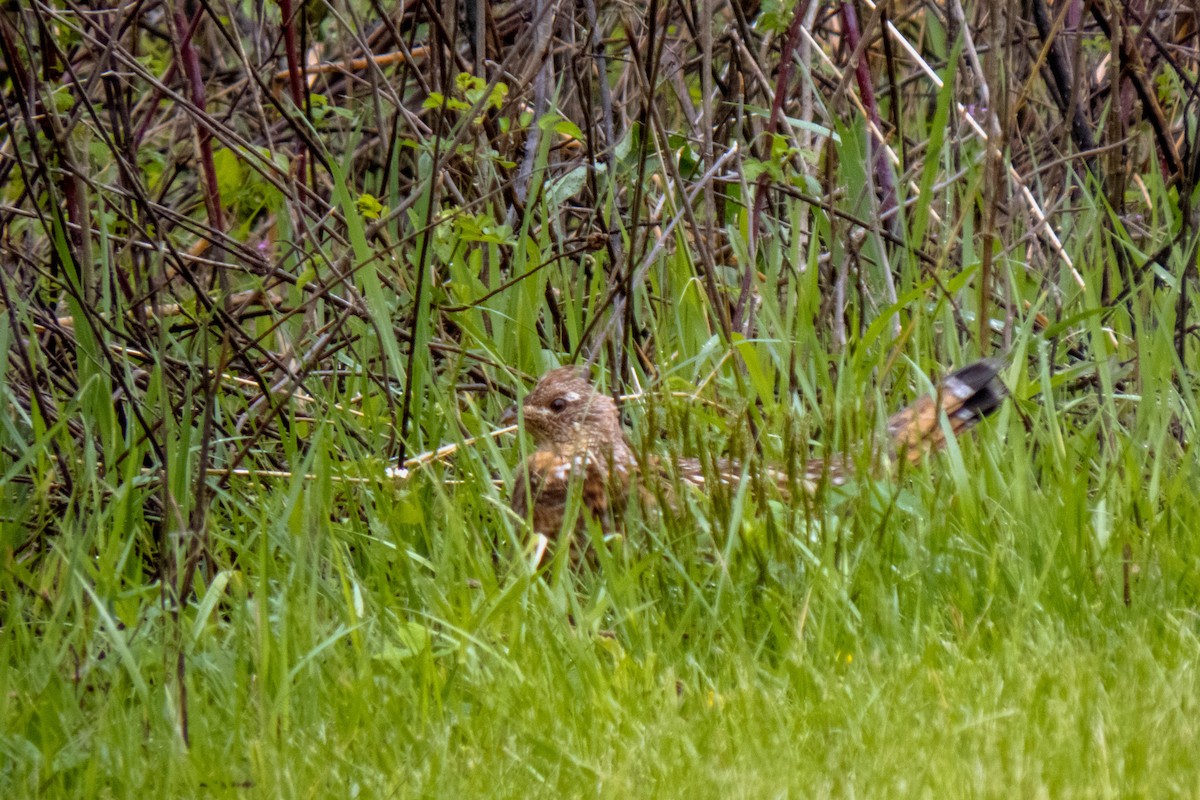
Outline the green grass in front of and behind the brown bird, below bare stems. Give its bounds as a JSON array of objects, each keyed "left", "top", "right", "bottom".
[{"left": 7, "top": 169, "right": 1200, "bottom": 798}]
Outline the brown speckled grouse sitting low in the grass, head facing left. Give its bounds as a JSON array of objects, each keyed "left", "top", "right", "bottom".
[{"left": 502, "top": 359, "right": 1007, "bottom": 536}]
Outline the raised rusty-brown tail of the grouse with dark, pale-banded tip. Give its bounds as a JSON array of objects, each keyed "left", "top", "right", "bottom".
[{"left": 888, "top": 359, "right": 1008, "bottom": 462}]
